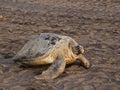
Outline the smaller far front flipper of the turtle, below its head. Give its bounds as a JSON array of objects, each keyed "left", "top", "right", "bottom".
[{"left": 77, "top": 54, "right": 91, "bottom": 69}]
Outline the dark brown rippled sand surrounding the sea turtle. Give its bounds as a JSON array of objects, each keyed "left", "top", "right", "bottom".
[{"left": 0, "top": 0, "right": 120, "bottom": 90}]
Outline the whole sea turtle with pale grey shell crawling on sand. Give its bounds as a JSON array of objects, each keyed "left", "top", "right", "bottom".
[{"left": 13, "top": 33, "right": 90, "bottom": 79}]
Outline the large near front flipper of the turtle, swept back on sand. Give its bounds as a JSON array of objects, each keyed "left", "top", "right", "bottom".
[{"left": 35, "top": 55, "right": 66, "bottom": 80}]
